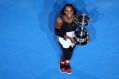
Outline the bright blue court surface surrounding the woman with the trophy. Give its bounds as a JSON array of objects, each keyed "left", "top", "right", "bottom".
[{"left": 0, "top": 0, "right": 119, "bottom": 79}]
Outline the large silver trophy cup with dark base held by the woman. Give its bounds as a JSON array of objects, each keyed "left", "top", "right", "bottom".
[{"left": 74, "top": 13, "right": 90, "bottom": 45}]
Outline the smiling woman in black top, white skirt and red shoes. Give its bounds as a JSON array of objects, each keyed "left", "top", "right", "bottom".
[{"left": 55, "top": 4, "right": 77, "bottom": 74}]
